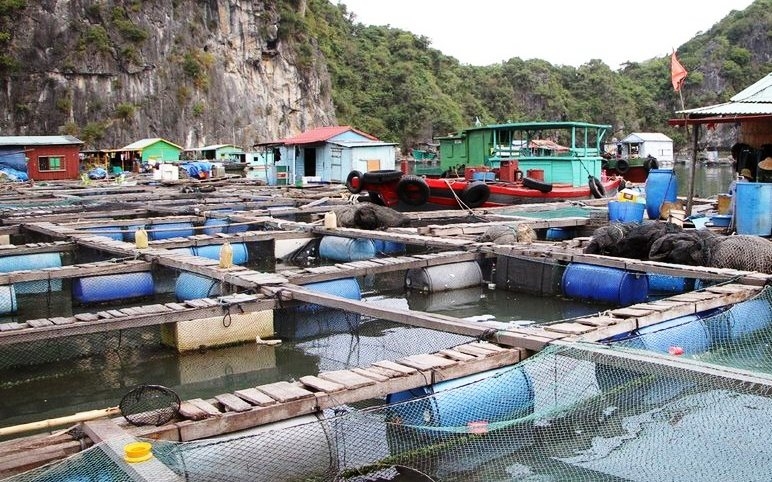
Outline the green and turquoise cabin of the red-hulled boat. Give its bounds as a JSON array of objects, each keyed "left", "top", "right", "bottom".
[{"left": 439, "top": 122, "right": 611, "bottom": 186}]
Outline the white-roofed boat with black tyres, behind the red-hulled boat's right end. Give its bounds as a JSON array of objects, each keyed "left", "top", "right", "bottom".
[{"left": 602, "top": 132, "right": 674, "bottom": 183}]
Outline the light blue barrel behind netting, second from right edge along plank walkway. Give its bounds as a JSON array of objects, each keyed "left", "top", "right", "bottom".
[{"left": 623, "top": 315, "right": 711, "bottom": 355}]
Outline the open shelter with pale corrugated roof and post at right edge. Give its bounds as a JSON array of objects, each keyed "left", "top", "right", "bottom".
[{"left": 668, "top": 72, "right": 772, "bottom": 215}]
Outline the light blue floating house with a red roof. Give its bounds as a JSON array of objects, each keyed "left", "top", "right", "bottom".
[{"left": 274, "top": 126, "right": 396, "bottom": 182}]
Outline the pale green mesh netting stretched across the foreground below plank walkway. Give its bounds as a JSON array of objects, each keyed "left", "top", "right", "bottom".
[{"left": 9, "top": 287, "right": 772, "bottom": 482}]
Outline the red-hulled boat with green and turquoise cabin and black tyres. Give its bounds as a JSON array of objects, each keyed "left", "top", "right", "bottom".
[{"left": 346, "top": 122, "right": 624, "bottom": 208}]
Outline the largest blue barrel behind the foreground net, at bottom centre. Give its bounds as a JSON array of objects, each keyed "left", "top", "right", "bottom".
[{"left": 386, "top": 366, "right": 534, "bottom": 428}]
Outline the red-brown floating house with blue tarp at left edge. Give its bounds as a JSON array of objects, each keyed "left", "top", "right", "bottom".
[{"left": 0, "top": 136, "right": 83, "bottom": 181}]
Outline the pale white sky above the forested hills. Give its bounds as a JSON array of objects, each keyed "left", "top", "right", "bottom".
[{"left": 331, "top": 0, "right": 753, "bottom": 70}]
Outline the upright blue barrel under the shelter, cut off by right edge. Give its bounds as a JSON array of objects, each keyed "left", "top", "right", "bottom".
[{"left": 734, "top": 182, "right": 772, "bottom": 236}]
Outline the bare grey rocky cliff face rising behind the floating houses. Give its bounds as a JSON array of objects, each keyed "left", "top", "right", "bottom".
[{"left": 0, "top": 0, "right": 335, "bottom": 148}]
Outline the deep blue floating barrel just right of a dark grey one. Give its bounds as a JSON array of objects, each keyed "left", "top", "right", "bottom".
[{"left": 563, "top": 263, "right": 649, "bottom": 306}]
